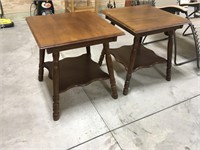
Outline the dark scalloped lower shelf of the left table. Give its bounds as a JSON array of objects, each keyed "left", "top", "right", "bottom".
[{"left": 44, "top": 54, "right": 109, "bottom": 92}]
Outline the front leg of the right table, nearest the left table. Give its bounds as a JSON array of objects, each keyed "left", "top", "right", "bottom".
[{"left": 123, "top": 36, "right": 142, "bottom": 95}]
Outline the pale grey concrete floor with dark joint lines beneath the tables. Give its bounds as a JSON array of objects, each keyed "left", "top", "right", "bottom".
[{"left": 0, "top": 12, "right": 200, "bottom": 150}]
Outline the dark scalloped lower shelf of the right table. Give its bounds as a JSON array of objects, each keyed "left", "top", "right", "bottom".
[{"left": 110, "top": 45, "right": 167, "bottom": 71}]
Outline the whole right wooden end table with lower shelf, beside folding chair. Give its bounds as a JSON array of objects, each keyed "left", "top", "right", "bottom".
[{"left": 99, "top": 5, "right": 189, "bottom": 95}]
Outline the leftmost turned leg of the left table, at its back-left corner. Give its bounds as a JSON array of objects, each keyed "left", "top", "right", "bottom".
[{"left": 38, "top": 49, "right": 45, "bottom": 81}]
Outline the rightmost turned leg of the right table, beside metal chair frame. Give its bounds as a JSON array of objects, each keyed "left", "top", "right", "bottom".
[{"left": 166, "top": 31, "right": 174, "bottom": 81}]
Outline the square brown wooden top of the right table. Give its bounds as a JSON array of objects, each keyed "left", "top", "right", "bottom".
[{"left": 103, "top": 5, "right": 189, "bottom": 34}]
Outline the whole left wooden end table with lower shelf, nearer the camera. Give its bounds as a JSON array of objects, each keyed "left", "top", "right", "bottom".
[{"left": 26, "top": 12, "right": 124, "bottom": 121}]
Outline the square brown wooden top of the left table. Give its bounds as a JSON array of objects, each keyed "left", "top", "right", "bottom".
[{"left": 26, "top": 12, "right": 124, "bottom": 49}]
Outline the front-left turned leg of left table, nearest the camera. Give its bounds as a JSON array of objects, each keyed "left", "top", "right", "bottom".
[{"left": 53, "top": 52, "right": 60, "bottom": 121}]
